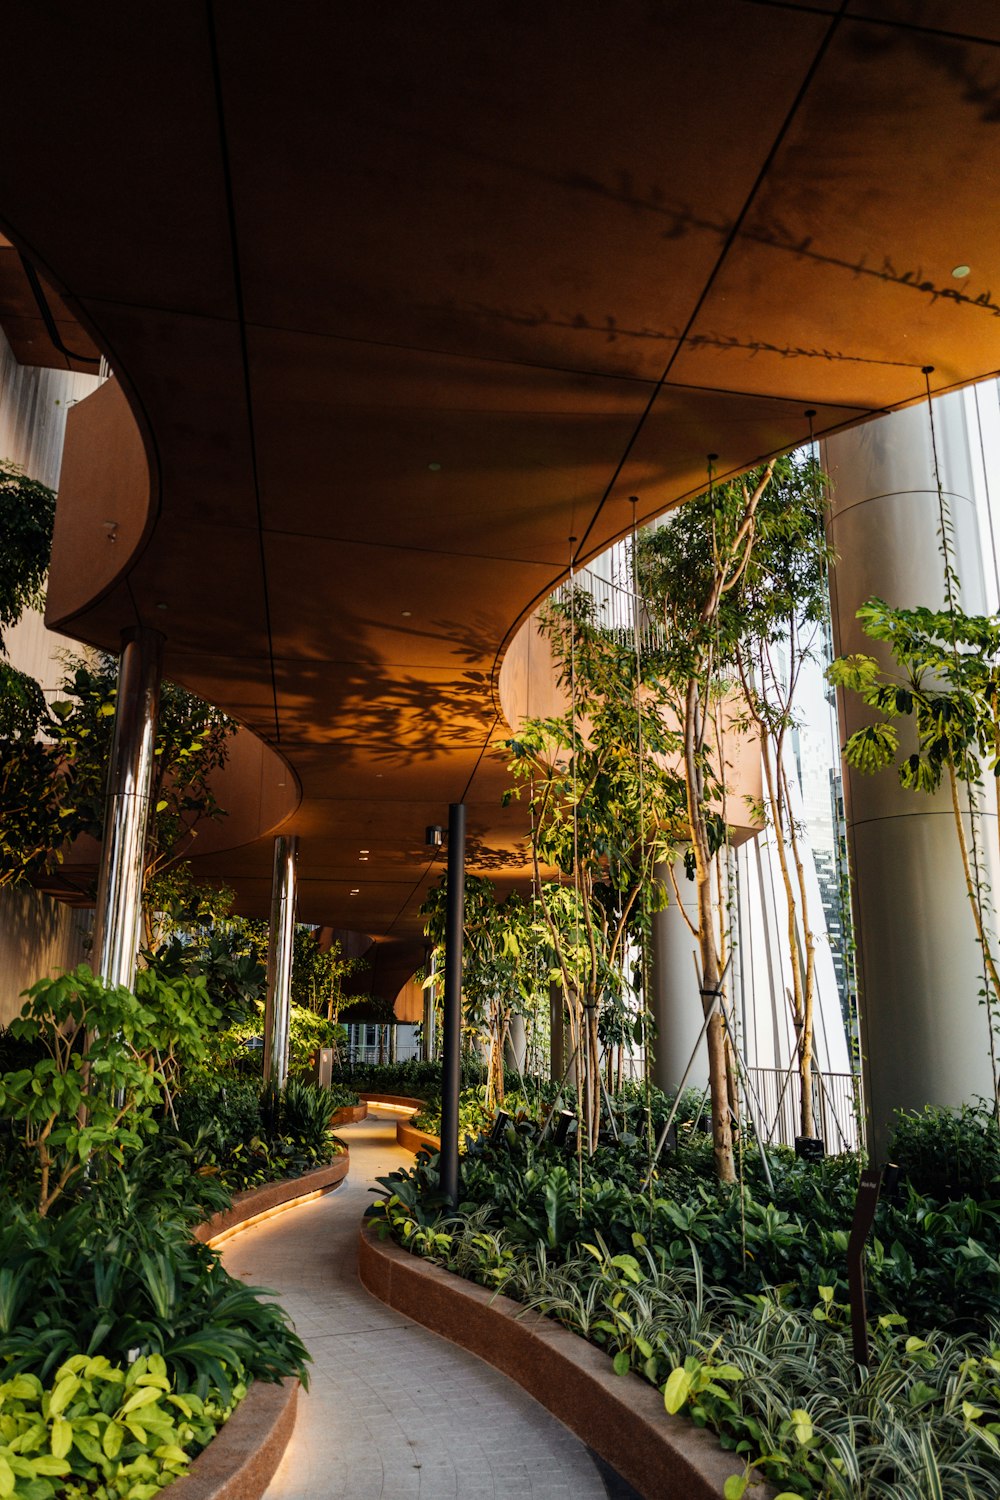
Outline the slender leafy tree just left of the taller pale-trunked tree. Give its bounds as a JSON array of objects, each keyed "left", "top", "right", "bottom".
[{"left": 508, "top": 587, "right": 682, "bottom": 1151}]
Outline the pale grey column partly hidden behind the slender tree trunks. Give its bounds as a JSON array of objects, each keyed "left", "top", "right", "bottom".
[{"left": 649, "top": 866, "right": 708, "bottom": 1094}]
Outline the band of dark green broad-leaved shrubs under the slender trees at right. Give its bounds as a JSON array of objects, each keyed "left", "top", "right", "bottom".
[{"left": 379, "top": 1121, "right": 1000, "bottom": 1332}]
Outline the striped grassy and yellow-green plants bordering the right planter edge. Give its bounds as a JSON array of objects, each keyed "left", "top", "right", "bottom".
[{"left": 375, "top": 1170, "right": 1000, "bottom": 1500}]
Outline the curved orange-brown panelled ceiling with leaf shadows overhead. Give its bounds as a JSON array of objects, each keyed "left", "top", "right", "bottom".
[{"left": 0, "top": 0, "right": 1000, "bottom": 987}]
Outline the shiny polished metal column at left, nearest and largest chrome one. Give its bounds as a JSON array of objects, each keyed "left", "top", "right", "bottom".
[{"left": 93, "top": 627, "right": 163, "bottom": 989}]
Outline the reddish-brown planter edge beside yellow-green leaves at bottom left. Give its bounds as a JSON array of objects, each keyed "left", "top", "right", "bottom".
[{"left": 169, "top": 1380, "right": 298, "bottom": 1500}]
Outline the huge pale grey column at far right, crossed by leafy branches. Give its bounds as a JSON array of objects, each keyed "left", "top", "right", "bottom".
[{"left": 823, "top": 393, "right": 1000, "bottom": 1161}]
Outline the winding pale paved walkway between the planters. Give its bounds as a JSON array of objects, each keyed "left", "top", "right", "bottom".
[{"left": 223, "top": 1118, "right": 616, "bottom": 1500}]
